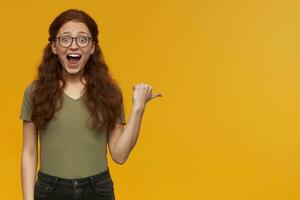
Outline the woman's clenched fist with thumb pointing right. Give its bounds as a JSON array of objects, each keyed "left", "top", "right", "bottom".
[{"left": 132, "top": 83, "right": 162, "bottom": 107}]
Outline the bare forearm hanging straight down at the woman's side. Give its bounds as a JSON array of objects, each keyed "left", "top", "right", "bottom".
[{"left": 21, "top": 152, "right": 37, "bottom": 200}]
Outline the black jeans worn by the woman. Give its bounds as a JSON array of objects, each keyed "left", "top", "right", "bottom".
[{"left": 34, "top": 169, "right": 115, "bottom": 200}]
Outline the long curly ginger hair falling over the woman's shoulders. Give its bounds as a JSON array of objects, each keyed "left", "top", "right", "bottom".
[{"left": 31, "top": 9, "right": 123, "bottom": 131}]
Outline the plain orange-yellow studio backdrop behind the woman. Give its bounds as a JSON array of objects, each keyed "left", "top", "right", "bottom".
[{"left": 0, "top": 0, "right": 300, "bottom": 200}]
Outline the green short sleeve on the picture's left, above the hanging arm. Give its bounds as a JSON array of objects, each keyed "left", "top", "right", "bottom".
[{"left": 19, "top": 85, "right": 32, "bottom": 121}]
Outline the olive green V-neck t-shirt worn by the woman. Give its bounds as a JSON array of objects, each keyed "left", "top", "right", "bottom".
[{"left": 19, "top": 82, "right": 126, "bottom": 178}]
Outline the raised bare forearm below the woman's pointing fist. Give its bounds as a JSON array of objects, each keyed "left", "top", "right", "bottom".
[{"left": 115, "top": 105, "right": 145, "bottom": 163}]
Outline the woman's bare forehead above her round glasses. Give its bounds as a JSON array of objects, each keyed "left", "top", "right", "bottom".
[{"left": 57, "top": 21, "right": 90, "bottom": 35}]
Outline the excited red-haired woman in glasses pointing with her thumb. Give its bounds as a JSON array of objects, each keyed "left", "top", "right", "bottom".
[{"left": 20, "top": 9, "right": 161, "bottom": 200}]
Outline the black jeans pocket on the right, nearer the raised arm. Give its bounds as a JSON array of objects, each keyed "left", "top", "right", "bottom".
[{"left": 94, "top": 176, "right": 115, "bottom": 200}]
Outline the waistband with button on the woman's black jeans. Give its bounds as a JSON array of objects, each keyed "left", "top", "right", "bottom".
[{"left": 38, "top": 168, "right": 110, "bottom": 186}]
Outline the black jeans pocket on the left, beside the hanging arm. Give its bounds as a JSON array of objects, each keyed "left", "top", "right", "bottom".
[{"left": 34, "top": 180, "right": 54, "bottom": 199}]
